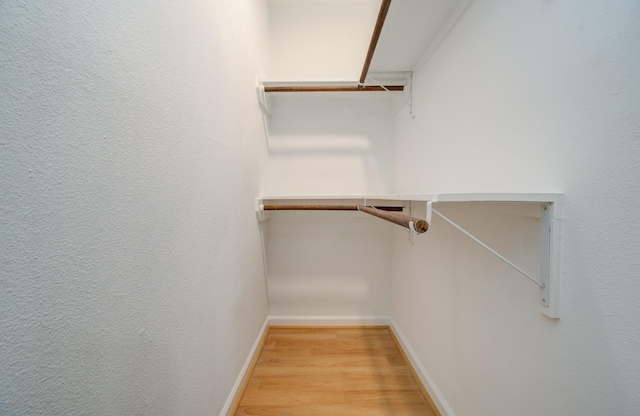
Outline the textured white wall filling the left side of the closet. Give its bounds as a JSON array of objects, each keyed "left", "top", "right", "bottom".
[{"left": 0, "top": 0, "right": 267, "bottom": 415}]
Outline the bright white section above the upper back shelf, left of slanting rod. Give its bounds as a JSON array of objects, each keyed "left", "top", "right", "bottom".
[{"left": 266, "top": 0, "right": 380, "bottom": 81}]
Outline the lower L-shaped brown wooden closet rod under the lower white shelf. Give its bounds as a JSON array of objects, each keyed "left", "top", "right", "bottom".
[{"left": 263, "top": 205, "right": 429, "bottom": 234}]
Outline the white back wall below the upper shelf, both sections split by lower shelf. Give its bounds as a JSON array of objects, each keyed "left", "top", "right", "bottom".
[{"left": 264, "top": 93, "right": 394, "bottom": 317}]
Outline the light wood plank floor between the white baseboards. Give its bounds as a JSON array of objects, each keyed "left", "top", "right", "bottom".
[{"left": 235, "top": 327, "right": 438, "bottom": 416}]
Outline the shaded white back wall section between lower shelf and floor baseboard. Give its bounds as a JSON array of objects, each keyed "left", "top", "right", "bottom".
[{"left": 267, "top": 211, "right": 392, "bottom": 317}]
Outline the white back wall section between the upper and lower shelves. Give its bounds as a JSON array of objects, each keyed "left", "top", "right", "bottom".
[{"left": 268, "top": 93, "right": 394, "bottom": 195}]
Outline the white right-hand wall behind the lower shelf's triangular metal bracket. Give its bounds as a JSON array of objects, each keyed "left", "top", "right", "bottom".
[{"left": 393, "top": 0, "right": 640, "bottom": 416}]
